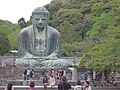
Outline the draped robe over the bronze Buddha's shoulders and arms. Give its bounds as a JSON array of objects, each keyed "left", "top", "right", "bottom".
[{"left": 18, "top": 26, "right": 60, "bottom": 58}]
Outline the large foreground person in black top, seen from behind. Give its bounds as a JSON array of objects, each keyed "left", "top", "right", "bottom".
[{"left": 58, "top": 76, "right": 71, "bottom": 90}]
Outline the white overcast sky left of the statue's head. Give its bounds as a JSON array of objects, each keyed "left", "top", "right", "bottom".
[{"left": 0, "top": 0, "right": 52, "bottom": 23}]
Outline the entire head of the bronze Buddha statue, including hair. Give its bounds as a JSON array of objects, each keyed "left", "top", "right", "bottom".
[{"left": 32, "top": 7, "right": 49, "bottom": 29}]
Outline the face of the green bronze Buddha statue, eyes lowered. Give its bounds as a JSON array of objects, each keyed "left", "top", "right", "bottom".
[{"left": 32, "top": 14, "right": 48, "bottom": 28}]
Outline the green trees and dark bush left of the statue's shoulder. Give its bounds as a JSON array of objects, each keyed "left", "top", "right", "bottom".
[{"left": 0, "top": 21, "right": 20, "bottom": 55}]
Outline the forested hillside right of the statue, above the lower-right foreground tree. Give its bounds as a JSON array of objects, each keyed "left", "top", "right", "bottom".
[{"left": 45, "top": 0, "right": 120, "bottom": 59}]
